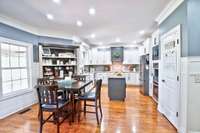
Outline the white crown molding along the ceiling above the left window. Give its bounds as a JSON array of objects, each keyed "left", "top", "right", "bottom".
[{"left": 0, "top": 14, "right": 73, "bottom": 40}]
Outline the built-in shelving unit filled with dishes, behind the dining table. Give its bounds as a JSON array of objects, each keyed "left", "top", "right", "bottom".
[{"left": 39, "top": 44, "right": 77, "bottom": 79}]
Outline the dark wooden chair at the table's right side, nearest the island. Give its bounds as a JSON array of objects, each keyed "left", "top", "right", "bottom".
[{"left": 78, "top": 79, "right": 103, "bottom": 125}]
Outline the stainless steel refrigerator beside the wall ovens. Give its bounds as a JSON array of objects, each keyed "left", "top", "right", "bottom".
[{"left": 140, "top": 54, "right": 149, "bottom": 96}]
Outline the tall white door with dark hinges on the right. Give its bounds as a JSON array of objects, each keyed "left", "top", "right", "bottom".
[{"left": 159, "top": 26, "right": 181, "bottom": 128}]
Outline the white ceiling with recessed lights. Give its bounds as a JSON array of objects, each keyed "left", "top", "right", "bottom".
[{"left": 0, "top": 0, "right": 170, "bottom": 45}]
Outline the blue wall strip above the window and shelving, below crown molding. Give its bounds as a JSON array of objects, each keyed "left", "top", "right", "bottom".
[{"left": 0, "top": 23, "right": 72, "bottom": 45}]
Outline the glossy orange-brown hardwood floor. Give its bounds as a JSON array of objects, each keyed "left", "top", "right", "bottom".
[{"left": 0, "top": 87, "right": 176, "bottom": 133}]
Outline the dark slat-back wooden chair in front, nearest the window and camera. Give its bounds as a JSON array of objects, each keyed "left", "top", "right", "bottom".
[{"left": 36, "top": 85, "right": 72, "bottom": 133}]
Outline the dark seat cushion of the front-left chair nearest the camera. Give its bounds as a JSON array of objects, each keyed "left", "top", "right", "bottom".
[{"left": 42, "top": 100, "right": 69, "bottom": 111}]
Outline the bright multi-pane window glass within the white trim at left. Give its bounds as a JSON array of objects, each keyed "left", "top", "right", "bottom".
[{"left": 0, "top": 43, "right": 29, "bottom": 95}]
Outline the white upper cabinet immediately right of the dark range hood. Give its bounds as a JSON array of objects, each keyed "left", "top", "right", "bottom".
[{"left": 123, "top": 48, "right": 140, "bottom": 64}]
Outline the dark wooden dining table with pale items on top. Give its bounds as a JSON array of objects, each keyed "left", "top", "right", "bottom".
[{"left": 59, "top": 80, "right": 93, "bottom": 122}]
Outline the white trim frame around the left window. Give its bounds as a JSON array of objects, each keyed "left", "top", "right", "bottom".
[{"left": 0, "top": 37, "right": 33, "bottom": 101}]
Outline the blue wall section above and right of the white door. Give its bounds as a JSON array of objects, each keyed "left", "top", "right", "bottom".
[{"left": 159, "top": 2, "right": 188, "bottom": 57}]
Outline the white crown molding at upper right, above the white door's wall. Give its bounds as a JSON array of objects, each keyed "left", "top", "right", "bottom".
[{"left": 155, "top": 0, "right": 184, "bottom": 25}]
